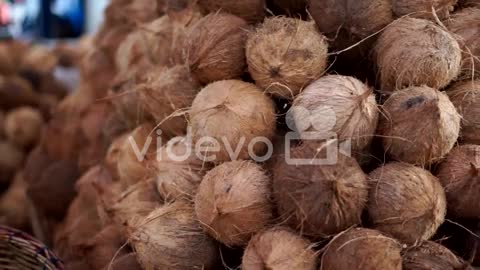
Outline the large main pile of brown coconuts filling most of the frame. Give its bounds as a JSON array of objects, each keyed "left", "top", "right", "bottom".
[{"left": 12, "top": 0, "right": 480, "bottom": 270}]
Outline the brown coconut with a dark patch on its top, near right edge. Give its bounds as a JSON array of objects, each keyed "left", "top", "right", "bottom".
[{"left": 378, "top": 86, "right": 461, "bottom": 165}]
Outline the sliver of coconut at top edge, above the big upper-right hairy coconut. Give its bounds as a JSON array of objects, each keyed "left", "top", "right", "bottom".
[{"left": 392, "top": 0, "right": 457, "bottom": 20}]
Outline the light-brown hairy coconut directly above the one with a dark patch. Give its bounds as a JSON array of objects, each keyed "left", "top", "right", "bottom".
[{"left": 375, "top": 18, "right": 462, "bottom": 91}]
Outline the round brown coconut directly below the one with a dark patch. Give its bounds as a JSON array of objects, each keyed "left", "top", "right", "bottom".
[{"left": 368, "top": 162, "right": 447, "bottom": 244}]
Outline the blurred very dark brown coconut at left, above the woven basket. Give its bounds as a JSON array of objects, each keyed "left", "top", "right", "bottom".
[{"left": 27, "top": 161, "right": 80, "bottom": 220}]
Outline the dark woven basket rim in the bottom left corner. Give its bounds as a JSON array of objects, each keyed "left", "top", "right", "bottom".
[{"left": 0, "top": 226, "right": 64, "bottom": 270}]
